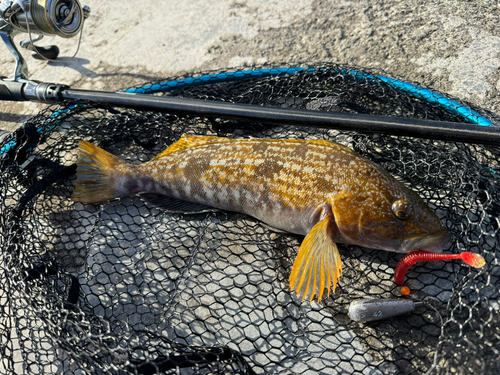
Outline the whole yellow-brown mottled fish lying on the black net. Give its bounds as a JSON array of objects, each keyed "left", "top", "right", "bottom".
[{"left": 72, "top": 134, "right": 451, "bottom": 302}]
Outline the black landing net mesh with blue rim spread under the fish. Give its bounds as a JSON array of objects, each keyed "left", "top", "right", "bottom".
[{"left": 0, "top": 65, "right": 500, "bottom": 374}]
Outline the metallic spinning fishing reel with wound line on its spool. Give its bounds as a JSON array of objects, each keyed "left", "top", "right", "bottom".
[{"left": 0, "top": 0, "right": 90, "bottom": 81}]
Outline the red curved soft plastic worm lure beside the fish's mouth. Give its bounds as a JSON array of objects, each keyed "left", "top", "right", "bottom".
[{"left": 394, "top": 250, "right": 486, "bottom": 285}]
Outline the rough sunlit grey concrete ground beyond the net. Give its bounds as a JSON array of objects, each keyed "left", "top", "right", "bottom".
[{"left": 0, "top": 0, "right": 500, "bottom": 130}]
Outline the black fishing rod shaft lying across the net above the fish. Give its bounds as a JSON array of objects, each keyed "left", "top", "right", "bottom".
[{"left": 0, "top": 81, "right": 500, "bottom": 146}]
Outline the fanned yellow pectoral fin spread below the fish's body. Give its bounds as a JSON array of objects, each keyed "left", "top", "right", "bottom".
[{"left": 290, "top": 215, "right": 342, "bottom": 302}]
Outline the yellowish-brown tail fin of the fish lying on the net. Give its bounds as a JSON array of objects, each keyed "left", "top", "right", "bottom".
[{"left": 72, "top": 141, "right": 131, "bottom": 203}]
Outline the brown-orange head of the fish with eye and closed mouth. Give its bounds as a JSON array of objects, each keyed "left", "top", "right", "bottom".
[{"left": 331, "top": 174, "right": 451, "bottom": 253}]
